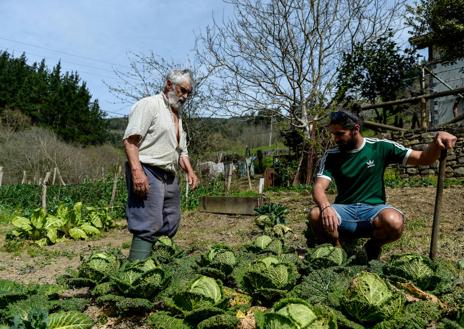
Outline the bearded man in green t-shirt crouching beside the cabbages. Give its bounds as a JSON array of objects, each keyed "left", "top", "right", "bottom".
[{"left": 310, "top": 111, "right": 456, "bottom": 260}]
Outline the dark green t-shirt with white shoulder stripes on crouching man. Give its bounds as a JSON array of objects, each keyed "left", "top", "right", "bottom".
[{"left": 317, "top": 138, "right": 412, "bottom": 204}]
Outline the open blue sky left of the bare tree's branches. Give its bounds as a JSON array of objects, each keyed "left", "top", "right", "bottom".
[{"left": 0, "top": 0, "right": 232, "bottom": 117}]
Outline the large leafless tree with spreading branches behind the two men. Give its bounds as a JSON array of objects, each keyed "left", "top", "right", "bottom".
[{"left": 198, "top": 0, "right": 404, "bottom": 182}]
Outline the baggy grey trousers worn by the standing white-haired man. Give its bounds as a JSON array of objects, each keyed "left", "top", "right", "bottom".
[{"left": 126, "top": 163, "right": 181, "bottom": 241}]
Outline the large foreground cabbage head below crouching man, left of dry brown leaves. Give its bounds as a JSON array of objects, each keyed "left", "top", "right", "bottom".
[{"left": 341, "top": 271, "right": 403, "bottom": 323}]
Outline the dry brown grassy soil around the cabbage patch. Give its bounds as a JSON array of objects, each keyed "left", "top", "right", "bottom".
[{"left": 0, "top": 186, "right": 464, "bottom": 329}]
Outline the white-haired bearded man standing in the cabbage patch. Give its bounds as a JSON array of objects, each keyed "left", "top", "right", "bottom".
[{"left": 123, "top": 69, "right": 198, "bottom": 260}]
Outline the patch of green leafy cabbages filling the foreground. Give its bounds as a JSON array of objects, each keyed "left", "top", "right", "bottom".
[{"left": 0, "top": 224, "right": 464, "bottom": 329}]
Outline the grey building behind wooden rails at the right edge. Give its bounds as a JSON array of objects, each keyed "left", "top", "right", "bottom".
[{"left": 410, "top": 37, "right": 464, "bottom": 128}]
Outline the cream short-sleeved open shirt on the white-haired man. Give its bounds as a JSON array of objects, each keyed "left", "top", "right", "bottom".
[{"left": 123, "top": 93, "right": 188, "bottom": 173}]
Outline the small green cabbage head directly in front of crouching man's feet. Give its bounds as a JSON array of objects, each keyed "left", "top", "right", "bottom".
[{"left": 305, "top": 243, "right": 348, "bottom": 269}]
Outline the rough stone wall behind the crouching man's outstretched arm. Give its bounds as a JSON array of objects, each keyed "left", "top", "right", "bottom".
[{"left": 386, "top": 128, "right": 464, "bottom": 178}]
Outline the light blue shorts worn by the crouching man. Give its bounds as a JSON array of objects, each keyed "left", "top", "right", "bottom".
[{"left": 332, "top": 203, "right": 401, "bottom": 238}]
